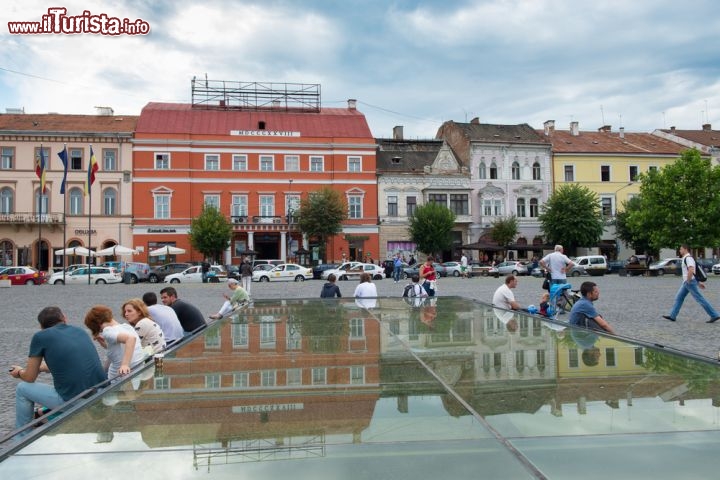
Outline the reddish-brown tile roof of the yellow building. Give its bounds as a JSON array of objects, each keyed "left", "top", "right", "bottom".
[{"left": 538, "top": 130, "right": 687, "bottom": 155}]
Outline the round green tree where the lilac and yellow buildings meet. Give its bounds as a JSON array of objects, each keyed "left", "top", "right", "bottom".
[{"left": 539, "top": 184, "right": 605, "bottom": 254}]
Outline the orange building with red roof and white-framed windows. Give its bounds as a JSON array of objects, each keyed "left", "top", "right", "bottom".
[{"left": 133, "top": 95, "right": 379, "bottom": 264}]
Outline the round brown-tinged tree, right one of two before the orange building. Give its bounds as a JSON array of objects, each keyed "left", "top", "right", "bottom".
[{"left": 297, "top": 187, "right": 348, "bottom": 259}]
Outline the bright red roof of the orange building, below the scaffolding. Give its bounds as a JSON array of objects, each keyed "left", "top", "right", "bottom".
[{"left": 137, "top": 103, "right": 374, "bottom": 138}]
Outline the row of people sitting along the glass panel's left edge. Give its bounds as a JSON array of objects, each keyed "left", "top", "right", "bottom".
[{"left": 9, "top": 287, "right": 207, "bottom": 434}]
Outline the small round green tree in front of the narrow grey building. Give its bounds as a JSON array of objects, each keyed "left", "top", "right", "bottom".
[{"left": 408, "top": 202, "right": 455, "bottom": 254}]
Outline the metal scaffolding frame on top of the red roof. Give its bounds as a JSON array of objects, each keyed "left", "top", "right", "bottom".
[{"left": 191, "top": 77, "right": 321, "bottom": 113}]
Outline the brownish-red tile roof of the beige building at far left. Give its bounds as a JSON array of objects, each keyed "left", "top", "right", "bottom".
[{"left": 0, "top": 113, "right": 138, "bottom": 134}]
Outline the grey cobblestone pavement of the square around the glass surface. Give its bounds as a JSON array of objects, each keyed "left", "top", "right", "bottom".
[{"left": 0, "top": 275, "right": 720, "bottom": 435}]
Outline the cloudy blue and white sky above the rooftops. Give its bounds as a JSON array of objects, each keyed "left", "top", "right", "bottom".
[{"left": 0, "top": 0, "right": 720, "bottom": 138}]
